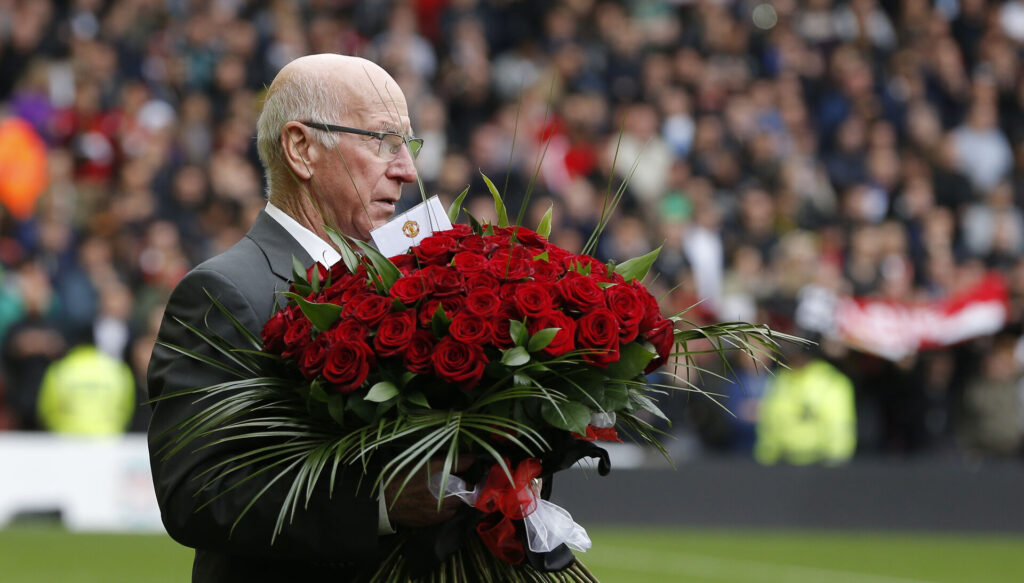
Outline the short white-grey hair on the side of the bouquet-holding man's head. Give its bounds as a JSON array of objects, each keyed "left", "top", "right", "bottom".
[{"left": 256, "top": 74, "right": 348, "bottom": 197}]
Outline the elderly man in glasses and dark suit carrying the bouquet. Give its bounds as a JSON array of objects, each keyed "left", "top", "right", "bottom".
[{"left": 148, "top": 54, "right": 457, "bottom": 583}]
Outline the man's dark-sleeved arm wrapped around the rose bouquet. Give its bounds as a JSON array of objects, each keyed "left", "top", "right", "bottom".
[{"left": 148, "top": 268, "right": 378, "bottom": 561}]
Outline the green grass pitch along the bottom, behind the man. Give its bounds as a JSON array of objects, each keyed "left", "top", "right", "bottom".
[{"left": 0, "top": 527, "right": 1024, "bottom": 583}]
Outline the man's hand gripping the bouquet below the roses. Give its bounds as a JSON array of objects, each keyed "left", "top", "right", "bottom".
[{"left": 384, "top": 456, "right": 473, "bottom": 528}]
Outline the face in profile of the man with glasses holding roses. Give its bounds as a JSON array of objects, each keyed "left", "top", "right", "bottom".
[{"left": 312, "top": 94, "right": 416, "bottom": 240}]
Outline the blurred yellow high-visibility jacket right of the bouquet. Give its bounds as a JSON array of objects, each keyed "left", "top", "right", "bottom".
[{"left": 754, "top": 361, "right": 857, "bottom": 464}]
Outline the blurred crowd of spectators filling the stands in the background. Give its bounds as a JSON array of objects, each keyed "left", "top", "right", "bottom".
[{"left": 0, "top": 0, "right": 1024, "bottom": 458}]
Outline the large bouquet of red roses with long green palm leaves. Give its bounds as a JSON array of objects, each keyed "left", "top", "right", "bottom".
[{"left": 153, "top": 189, "right": 790, "bottom": 582}]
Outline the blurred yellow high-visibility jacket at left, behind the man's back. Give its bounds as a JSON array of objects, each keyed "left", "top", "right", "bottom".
[{"left": 38, "top": 345, "right": 135, "bottom": 435}]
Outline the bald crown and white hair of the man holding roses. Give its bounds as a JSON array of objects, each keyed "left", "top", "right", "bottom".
[{"left": 256, "top": 53, "right": 407, "bottom": 193}]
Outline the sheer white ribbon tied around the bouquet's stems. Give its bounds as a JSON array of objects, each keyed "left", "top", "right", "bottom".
[{"left": 429, "top": 473, "right": 592, "bottom": 552}]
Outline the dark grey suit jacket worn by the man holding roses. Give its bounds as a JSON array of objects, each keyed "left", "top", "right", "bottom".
[{"left": 148, "top": 212, "right": 379, "bottom": 583}]
